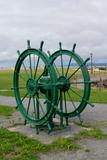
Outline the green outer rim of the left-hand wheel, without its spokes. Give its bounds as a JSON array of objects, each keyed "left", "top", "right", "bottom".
[{"left": 13, "top": 48, "right": 57, "bottom": 126}]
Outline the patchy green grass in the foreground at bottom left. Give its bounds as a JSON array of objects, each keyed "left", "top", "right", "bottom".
[{"left": 0, "top": 128, "right": 79, "bottom": 160}]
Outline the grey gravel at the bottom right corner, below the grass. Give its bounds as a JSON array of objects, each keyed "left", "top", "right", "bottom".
[{"left": 40, "top": 140, "right": 107, "bottom": 160}]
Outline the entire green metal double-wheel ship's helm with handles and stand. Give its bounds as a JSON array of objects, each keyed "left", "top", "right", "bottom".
[{"left": 13, "top": 41, "right": 93, "bottom": 133}]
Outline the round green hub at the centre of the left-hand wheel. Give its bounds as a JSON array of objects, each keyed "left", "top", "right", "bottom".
[{"left": 26, "top": 78, "right": 38, "bottom": 96}]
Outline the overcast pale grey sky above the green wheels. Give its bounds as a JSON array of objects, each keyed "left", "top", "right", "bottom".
[{"left": 0, "top": 0, "right": 107, "bottom": 63}]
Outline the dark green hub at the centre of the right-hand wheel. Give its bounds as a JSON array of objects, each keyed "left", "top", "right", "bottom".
[{"left": 58, "top": 76, "right": 70, "bottom": 92}]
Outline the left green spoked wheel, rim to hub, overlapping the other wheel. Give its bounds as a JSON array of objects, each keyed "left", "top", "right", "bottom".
[{"left": 13, "top": 48, "right": 57, "bottom": 125}]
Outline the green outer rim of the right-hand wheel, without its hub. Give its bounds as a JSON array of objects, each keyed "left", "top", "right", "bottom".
[{"left": 50, "top": 49, "right": 91, "bottom": 117}]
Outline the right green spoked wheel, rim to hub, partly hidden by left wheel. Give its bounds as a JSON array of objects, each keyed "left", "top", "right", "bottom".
[{"left": 50, "top": 49, "right": 91, "bottom": 117}]
